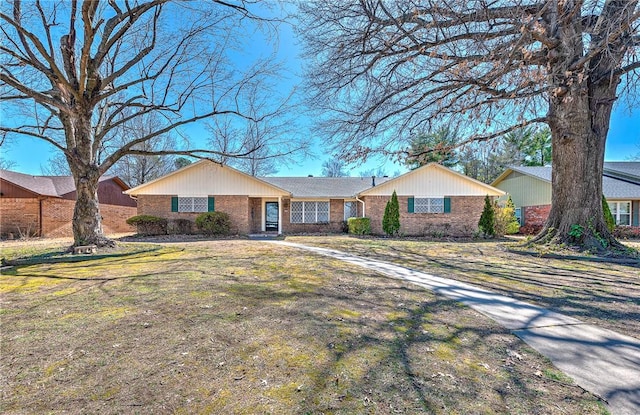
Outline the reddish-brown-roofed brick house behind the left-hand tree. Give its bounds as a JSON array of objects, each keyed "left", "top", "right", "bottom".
[{"left": 0, "top": 170, "right": 136, "bottom": 237}]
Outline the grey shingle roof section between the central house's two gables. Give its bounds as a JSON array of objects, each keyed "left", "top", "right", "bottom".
[{"left": 259, "top": 177, "right": 389, "bottom": 199}]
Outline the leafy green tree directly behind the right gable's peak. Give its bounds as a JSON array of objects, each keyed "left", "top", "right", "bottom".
[{"left": 403, "top": 127, "right": 459, "bottom": 169}]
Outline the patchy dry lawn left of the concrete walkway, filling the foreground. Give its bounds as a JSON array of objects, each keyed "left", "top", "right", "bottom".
[{"left": 0, "top": 240, "right": 612, "bottom": 414}]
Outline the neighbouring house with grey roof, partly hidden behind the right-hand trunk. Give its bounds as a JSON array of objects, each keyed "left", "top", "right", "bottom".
[{"left": 491, "top": 161, "right": 640, "bottom": 233}]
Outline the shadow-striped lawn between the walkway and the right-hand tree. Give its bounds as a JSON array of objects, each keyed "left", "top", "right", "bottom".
[{"left": 287, "top": 236, "right": 640, "bottom": 338}]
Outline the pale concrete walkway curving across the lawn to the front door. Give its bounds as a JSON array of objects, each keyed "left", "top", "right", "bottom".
[{"left": 273, "top": 241, "right": 640, "bottom": 415}]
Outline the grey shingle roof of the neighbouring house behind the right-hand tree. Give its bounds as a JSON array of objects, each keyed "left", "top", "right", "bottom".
[{"left": 502, "top": 162, "right": 640, "bottom": 199}]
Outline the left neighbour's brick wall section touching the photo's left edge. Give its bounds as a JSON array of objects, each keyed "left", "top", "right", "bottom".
[{"left": 0, "top": 197, "right": 40, "bottom": 238}]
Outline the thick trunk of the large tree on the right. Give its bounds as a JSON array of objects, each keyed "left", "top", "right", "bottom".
[{"left": 534, "top": 5, "right": 623, "bottom": 252}]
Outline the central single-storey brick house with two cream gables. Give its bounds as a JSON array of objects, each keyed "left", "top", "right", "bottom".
[{"left": 125, "top": 160, "right": 504, "bottom": 236}]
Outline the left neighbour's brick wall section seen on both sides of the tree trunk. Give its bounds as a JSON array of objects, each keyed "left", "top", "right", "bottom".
[{"left": 42, "top": 198, "right": 136, "bottom": 238}]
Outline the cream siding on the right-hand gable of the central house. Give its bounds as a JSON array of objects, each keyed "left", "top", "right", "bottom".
[{"left": 361, "top": 164, "right": 502, "bottom": 197}]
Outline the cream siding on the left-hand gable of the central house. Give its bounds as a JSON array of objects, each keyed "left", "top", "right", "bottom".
[{"left": 127, "top": 161, "right": 288, "bottom": 197}]
